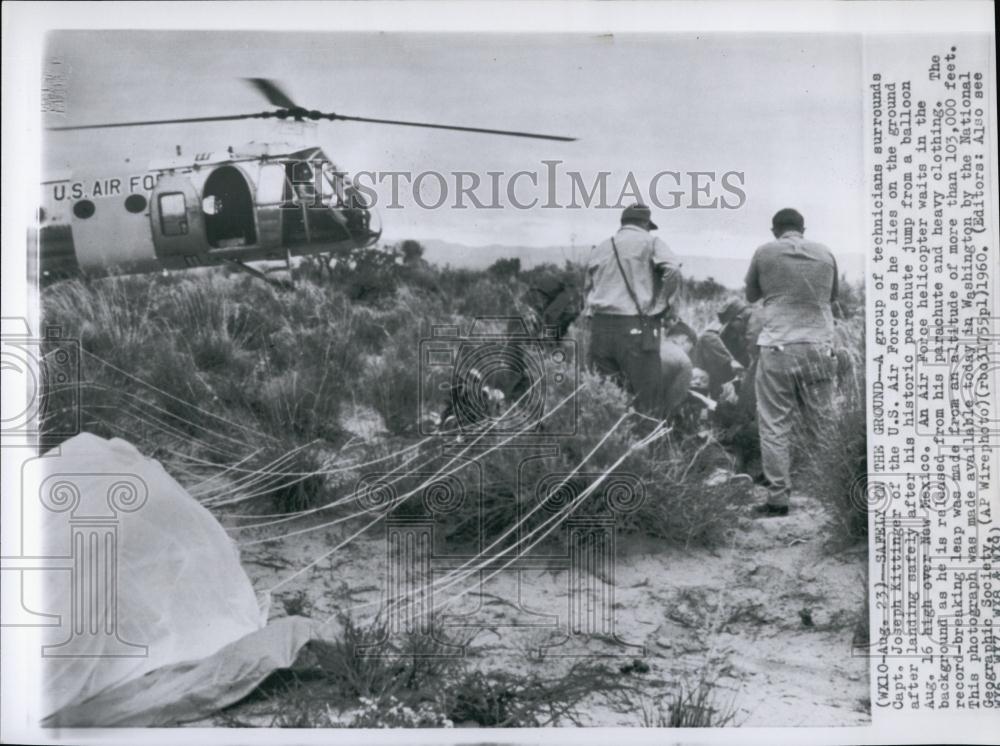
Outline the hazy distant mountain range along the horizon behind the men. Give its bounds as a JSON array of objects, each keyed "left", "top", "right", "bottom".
[{"left": 420, "top": 239, "right": 865, "bottom": 288}]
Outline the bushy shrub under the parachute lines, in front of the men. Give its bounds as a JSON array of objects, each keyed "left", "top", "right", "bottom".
[{"left": 426, "top": 371, "right": 751, "bottom": 552}]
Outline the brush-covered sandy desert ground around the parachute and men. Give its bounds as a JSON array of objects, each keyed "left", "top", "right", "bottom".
[{"left": 42, "top": 247, "right": 870, "bottom": 727}]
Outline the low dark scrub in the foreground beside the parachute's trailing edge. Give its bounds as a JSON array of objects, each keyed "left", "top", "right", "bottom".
[{"left": 228, "top": 618, "right": 636, "bottom": 728}]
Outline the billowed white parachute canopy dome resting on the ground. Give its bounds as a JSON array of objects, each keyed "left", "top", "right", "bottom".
[{"left": 14, "top": 434, "right": 304, "bottom": 725}]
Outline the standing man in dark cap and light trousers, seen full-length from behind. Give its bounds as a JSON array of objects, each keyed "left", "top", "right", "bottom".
[{"left": 746, "top": 208, "right": 837, "bottom": 516}]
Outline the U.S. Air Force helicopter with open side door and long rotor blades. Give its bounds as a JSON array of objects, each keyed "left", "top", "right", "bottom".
[{"left": 37, "top": 78, "right": 576, "bottom": 284}]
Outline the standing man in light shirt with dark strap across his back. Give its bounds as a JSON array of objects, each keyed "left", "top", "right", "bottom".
[{"left": 586, "top": 205, "right": 680, "bottom": 415}]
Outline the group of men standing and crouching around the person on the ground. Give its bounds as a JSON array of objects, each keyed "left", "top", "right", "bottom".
[{"left": 585, "top": 205, "right": 838, "bottom": 517}]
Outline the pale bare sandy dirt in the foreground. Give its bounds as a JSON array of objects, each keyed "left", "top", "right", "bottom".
[{"left": 219, "top": 488, "right": 870, "bottom": 726}]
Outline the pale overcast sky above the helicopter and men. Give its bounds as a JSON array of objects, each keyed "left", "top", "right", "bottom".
[{"left": 43, "top": 31, "right": 865, "bottom": 258}]
